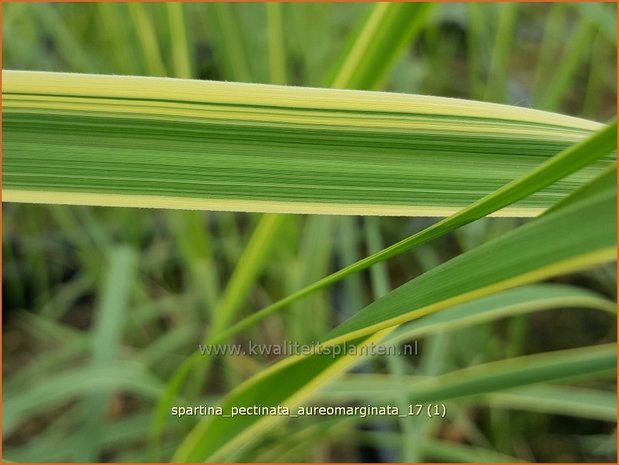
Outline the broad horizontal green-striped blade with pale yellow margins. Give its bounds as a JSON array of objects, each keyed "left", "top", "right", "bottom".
[{"left": 2, "top": 71, "right": 608, "bottom": 216}]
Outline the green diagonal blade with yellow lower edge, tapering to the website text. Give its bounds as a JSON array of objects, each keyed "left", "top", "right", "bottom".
[{"left": 325, "top": 179, "right": 617, "bottom": 343}]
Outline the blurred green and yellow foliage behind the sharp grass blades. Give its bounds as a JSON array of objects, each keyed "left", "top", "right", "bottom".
[{"left": 2, "top": 3, "right": 616, "bottom": 462}]
